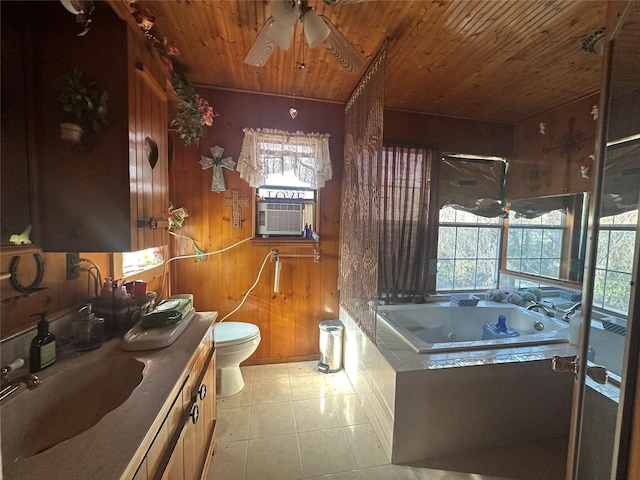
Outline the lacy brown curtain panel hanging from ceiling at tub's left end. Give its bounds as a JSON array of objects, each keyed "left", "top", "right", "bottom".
[{"left": 339, "top": 48, "right": 386, "bottom": 343}]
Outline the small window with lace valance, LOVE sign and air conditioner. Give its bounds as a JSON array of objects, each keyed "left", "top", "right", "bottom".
[{"left": 238, "top": 128, "right": 332, "bottom": 238}]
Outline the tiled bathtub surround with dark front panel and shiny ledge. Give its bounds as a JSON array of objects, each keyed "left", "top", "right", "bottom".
[{"left": 340, "top": 310, "right": 575, "bottom": 478}]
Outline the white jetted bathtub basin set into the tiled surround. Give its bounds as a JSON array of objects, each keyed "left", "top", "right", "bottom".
[{"left": 378, "top": 301, "right": 569, "bottom": 353}]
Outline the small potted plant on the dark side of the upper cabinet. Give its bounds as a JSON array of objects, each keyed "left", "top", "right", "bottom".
[{"left": 60, "top": 67, "right": 109, "bottom": 143}]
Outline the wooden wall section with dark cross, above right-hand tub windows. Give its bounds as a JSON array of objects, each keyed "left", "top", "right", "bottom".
[{"left": 506, "top": 95, "right": 598, "bottom": 199}]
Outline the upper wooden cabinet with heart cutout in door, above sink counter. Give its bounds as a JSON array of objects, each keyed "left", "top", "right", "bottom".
[{"left": 2, "top": 2, "right": 169, "bottom": 252}]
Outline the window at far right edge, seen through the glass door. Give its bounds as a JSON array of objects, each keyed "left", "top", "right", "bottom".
[{"left": 593, "top": 209, "right": 638, "bottom": 315}]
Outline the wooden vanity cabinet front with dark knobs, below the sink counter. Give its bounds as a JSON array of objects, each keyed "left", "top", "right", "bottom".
[{"left": 134, "top": 327, "right": 216, "bottom": 480}]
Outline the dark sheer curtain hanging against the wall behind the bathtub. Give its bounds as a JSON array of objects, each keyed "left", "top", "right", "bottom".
[{"left": 378, "top": 146, "right": 437, "bottom": 303}]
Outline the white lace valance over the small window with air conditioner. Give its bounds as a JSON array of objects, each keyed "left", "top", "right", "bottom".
[{"left": 236, "top": 128, "right": 333, "bottom": 188}]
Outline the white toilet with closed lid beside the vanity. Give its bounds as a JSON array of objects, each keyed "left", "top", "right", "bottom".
[{"left": 213, "top": 322, "right": 260, "bottom": 398}]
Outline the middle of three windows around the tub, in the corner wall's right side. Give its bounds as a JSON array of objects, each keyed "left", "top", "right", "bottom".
[{"left": 506, "top": 210, "right": 566, "bottom": 278}]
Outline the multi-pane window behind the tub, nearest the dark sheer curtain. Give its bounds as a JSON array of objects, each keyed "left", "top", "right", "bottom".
[{"left": 436, "top": 206, "right": 502, "bottom": 291}]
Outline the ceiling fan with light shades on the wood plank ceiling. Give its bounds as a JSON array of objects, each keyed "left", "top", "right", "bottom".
[{"left": 244, "top": 0, "right": 365, "bottom": 72}]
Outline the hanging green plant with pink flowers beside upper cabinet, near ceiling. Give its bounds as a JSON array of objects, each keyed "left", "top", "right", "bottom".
[{"left": 171, "top": 72, "right": 215, "bottom": 145}]
